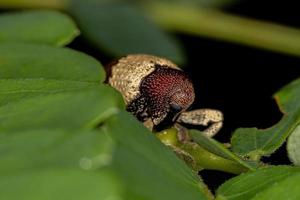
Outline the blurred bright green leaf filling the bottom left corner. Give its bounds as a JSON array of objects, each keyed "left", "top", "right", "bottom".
[{"left": 0, "top": 168, "right": 122, "bottom": 200}]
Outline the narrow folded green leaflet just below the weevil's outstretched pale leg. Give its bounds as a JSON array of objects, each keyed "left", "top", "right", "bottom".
[{"left": 189, "top": 130, "right": 257, "bottom": 170}]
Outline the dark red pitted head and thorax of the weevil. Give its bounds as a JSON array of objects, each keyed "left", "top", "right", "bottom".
[{"left": 140, "top": 65, "right": 195, "bottom": 122}]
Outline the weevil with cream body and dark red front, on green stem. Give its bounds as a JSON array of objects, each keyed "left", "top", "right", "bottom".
[{"left": 105, "top": 54, "right": 223, "bottom": 137}]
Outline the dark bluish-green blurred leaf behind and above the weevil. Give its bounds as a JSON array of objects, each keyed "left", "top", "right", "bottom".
[{"left": 71, "top": 0, "right": 184, "bottom": 64}]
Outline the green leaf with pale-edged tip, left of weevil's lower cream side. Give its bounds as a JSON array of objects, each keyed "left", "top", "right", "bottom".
[{"left": 0, "top": 86, "right": 121, "bottom": 132}]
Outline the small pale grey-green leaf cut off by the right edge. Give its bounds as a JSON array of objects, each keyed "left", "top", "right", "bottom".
[{"left": 287, "top": 124, "right": 300, "bottom": 166}]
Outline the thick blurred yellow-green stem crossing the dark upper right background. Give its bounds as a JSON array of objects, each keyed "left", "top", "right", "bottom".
[{"left": 144, "top": 1, "right": 300, "bottom": 56}]
